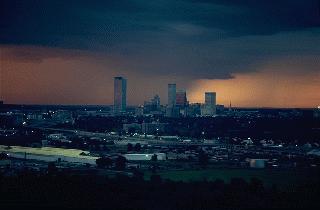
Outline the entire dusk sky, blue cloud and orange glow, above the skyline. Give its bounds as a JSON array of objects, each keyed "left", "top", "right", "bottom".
[{"left": 0, "top": 0, "right": 320, "bottom": 107}]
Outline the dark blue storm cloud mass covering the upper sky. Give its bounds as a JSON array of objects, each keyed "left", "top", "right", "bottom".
[{"left": 0, "top": 0, "right": 320, "bottom": 78}]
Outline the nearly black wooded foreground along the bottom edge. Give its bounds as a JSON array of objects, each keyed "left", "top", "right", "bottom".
[{"left": 0, "top": 168, "right": 320, "bottom": 210}]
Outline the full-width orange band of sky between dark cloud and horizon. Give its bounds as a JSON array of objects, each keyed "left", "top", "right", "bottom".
[{"left": 0, "top": 46, "right": 320, "bottom": 108}]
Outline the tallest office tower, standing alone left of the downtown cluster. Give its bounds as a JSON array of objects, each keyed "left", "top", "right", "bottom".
[{"left": 113, "top": 77, "right": 127, "bottom": 113}]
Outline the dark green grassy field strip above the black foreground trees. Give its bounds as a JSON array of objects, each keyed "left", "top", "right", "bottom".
[{"left": 144, "top": 168, "right": 320, "bottom": 188}]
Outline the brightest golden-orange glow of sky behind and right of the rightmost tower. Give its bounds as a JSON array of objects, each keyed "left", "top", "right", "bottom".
[{"left": 188, "top": 70, "right": 320, "bottom": 108}]
